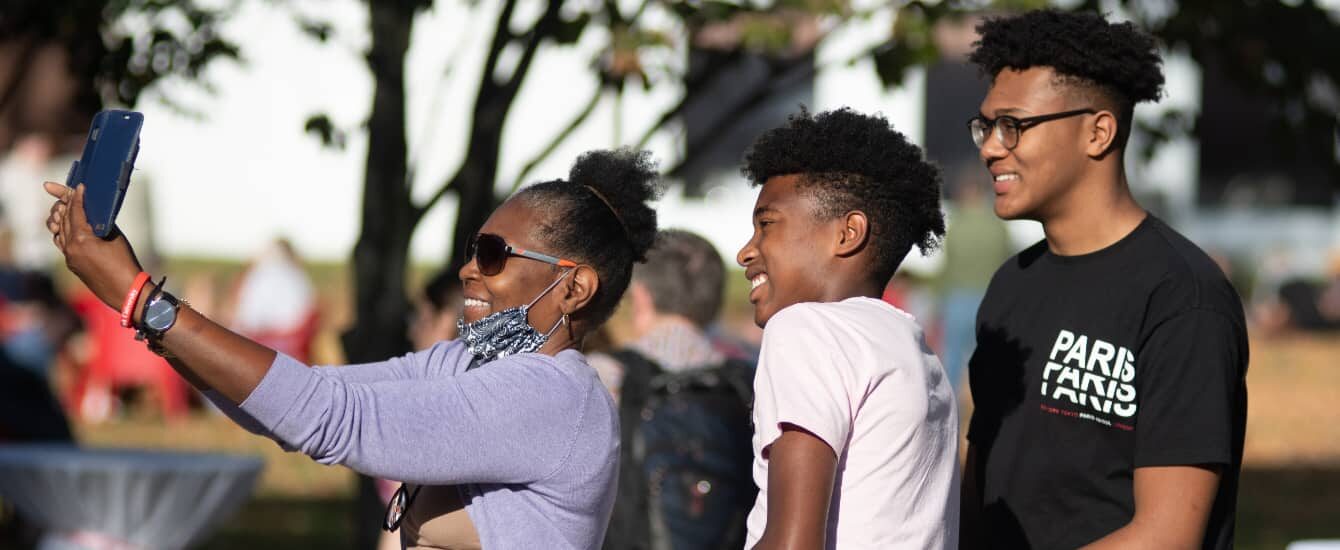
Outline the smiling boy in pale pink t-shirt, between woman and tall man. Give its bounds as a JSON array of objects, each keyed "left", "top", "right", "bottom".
[{"left": 737, "top": 109, "right": 959, "bottom": 550}]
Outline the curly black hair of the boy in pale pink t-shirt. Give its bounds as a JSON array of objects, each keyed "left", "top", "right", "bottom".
[{"left": 741, "top": 109, "right": 945, "bottom": 280}]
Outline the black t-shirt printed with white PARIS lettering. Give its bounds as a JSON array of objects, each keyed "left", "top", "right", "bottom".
[{"left": 967, "top": 216, "right": 1248, "bottom": 549}]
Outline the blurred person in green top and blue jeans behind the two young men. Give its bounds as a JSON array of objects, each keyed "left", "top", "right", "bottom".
[{"left": 935, "top": 165, "right": 1013, "bottom": 392}]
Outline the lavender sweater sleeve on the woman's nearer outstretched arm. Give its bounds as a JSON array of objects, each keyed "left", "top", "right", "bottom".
[{"left": 240, "top": 354, "right": 586, "bottom": 484}]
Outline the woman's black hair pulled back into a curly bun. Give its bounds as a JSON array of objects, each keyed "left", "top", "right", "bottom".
[{"left": 516, "top": 149, "right": 661, "bottom": 325}]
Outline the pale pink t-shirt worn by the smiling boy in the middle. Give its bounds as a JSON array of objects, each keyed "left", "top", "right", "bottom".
[{"left": 746, "top": 298, "right": 958, "bottom": 549}]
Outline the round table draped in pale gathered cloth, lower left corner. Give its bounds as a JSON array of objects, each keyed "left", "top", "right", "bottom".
[{"left": 0, "top": 444, "right": 263, "bottom": 550}]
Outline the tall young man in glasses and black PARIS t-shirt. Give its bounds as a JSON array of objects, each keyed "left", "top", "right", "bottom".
[{"left": 962, "top": 11, "right": 1248, "bottom": 549}]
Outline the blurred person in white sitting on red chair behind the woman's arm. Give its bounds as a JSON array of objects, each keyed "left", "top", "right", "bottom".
[{"left": 228, "top": 239, "right": 320, "bottom": 362}]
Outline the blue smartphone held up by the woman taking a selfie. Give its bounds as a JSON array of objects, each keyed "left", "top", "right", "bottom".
[{"left": 66, "top": 110, "right": 145, "bottom": 239}]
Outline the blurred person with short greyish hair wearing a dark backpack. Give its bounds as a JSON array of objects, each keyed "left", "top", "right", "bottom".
[{"left": 605, "top": 229, "right": 757, "bottom": 550}]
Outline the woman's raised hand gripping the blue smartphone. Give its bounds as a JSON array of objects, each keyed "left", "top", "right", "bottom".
[{"left": 43, "top": 181, "right": 142, "bottom": 309}]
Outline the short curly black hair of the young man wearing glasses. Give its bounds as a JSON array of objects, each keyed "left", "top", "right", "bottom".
[{"left": 969, "top": 9, "right": 1163, "bottom": 111}]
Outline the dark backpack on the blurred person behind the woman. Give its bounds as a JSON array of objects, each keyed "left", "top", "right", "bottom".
[{"left": 604, "top": 350, "right": 758, "bottom": 550}]
